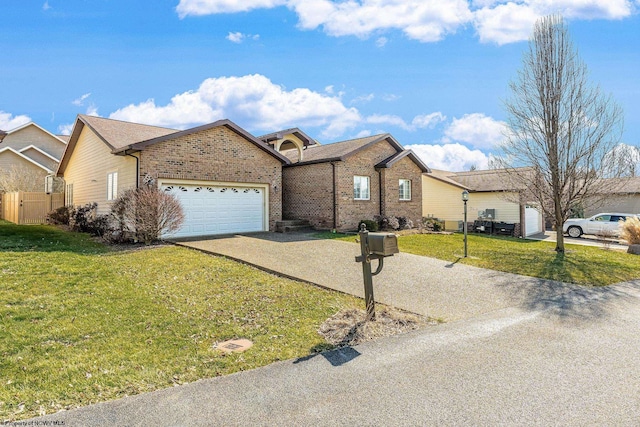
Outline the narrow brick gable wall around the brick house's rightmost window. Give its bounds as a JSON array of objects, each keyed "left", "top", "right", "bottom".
[{"left": 382, "top": 157, "right": 422, "bottom": 226}]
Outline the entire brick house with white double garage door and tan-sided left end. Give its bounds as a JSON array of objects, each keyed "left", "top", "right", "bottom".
[{"left": 57, "top": 115, "right": 429, "bottom": 237}]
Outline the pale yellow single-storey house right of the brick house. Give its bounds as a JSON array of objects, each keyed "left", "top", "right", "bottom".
[{"left": 422, "top": 169, "right": 543, "bottom": 237}]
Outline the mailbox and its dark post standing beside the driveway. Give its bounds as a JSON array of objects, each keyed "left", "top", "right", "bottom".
[{"left": 356, "top": 224, "right": 400, "bottom": 321}]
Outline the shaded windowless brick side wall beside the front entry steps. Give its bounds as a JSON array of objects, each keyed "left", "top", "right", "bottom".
[{"left": 282, "top": 163, "right": 333, "bottom": 229}]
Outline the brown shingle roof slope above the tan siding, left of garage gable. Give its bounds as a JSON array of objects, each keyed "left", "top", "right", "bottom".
[{"left": 78, "top": 114, "right": 178, "bottom": 151}]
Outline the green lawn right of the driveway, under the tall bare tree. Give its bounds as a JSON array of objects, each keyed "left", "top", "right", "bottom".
[{"left": 316, "top": 233, "right": 640, "bottom": 286}]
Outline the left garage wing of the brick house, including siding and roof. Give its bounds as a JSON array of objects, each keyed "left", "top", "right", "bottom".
[{"left": 57, "top": 115, "right": 288, "bottom": 237}]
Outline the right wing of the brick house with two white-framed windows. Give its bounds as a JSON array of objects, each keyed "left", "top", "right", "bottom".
[{"left": 282, "top": 134, "right": 429, "bottom": 231}]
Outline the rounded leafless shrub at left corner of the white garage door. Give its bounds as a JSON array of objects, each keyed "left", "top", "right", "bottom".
[{"left": 111, "top": 185, "right": 184, "bottom": 245}]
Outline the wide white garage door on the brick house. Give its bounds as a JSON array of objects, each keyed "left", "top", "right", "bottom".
[{"left": 160, "top": 183, "right": 267, "bottom": 237}]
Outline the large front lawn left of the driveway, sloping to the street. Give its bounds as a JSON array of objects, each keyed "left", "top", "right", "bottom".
[{"left": 0, "top": 221, "right": 362, "bottom": 421}]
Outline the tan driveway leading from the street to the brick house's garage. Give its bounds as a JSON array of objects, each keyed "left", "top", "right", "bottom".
[{"left": 179, "top": 233, "right": 583, "bottom": 321}]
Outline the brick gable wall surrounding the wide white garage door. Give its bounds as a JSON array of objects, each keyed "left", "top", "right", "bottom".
[{"left": 140, "top": 126, "right": 282, "bottom": 230}]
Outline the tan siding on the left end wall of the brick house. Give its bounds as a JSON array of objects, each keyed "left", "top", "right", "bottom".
[{"left": 64, "top": 126, "right": 136, "bottom": 214}]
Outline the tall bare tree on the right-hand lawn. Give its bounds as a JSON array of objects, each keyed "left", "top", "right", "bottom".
[{"left": 494, "top": 15, "right": 623, "bottom": 253}]
